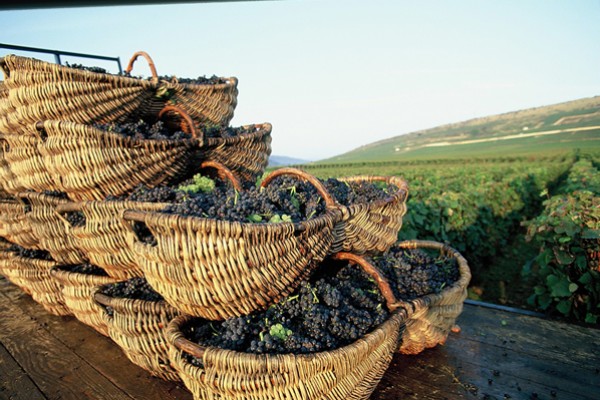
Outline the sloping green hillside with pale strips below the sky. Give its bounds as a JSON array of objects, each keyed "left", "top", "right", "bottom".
[{"left": 319, "top": 96, "right": 600, "bottom": 163}]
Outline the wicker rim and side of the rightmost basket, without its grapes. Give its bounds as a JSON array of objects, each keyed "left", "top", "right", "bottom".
[{"left": 397, "top": 240, "right": 471, "bottom": 354}]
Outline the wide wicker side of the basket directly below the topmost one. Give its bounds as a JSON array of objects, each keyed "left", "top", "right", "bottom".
[{"left": 40, "top": 121, "right": 197, "bottom": 200}]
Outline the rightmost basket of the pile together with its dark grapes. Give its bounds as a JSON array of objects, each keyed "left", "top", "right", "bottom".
[{"left": 353, "top": 240, "right": 471, "bottom": 354}]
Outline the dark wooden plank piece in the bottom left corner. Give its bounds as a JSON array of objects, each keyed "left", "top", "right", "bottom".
[{"left": 0, "top": 343, "right": 46, "bottom": 400}]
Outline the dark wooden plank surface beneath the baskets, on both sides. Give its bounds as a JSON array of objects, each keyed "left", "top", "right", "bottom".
[{"left": 0, "top": 278, "right": 600, "bottom": 400}]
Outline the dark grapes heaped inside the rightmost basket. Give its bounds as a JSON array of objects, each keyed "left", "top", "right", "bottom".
[{"left": 373, "top": 247, "right": 459, "bottom": 301}]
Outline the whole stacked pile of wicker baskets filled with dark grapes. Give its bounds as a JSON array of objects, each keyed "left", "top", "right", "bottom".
[{"left": 0, "top": 52, "right": 470, "bottom": 399}]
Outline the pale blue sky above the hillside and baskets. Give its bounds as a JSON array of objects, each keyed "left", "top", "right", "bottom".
[{"left": 0, "top": 0, "right": 600, "bottom": 161}]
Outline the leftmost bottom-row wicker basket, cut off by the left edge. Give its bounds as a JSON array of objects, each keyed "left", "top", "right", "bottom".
[{"left": 0, "top": 252, "right": 71, "bottom": 315}]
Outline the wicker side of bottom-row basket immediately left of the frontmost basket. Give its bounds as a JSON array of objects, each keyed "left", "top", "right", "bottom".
[{"left": 94, "top": 286, "right": 180, "bottom": 381}]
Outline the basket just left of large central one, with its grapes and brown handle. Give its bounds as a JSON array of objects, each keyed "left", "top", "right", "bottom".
[{"left": 56, "top": 161, "right": 242, "bottom": 280}]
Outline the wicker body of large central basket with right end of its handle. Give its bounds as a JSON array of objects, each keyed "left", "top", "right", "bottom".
[{"left": 124, "top": 169, "right": 341, "bottom": 320}]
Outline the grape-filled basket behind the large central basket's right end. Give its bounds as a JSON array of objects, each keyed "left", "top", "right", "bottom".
[{"left": 265, "top": 168, "right": 408, "bottom": 253}]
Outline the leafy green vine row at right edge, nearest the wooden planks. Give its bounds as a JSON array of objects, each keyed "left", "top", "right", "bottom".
[{"left": 523, "top": 160, "right": 600, "bottom": 324}]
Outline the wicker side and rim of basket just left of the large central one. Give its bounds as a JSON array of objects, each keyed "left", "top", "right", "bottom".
[{"left": 68, "top": 201, "right": 166, "bottom": 280}]
